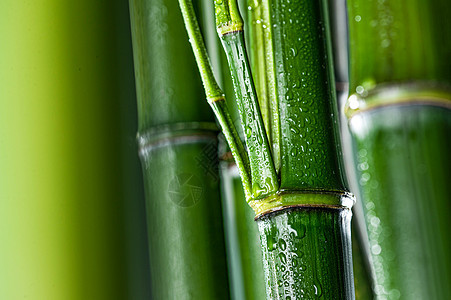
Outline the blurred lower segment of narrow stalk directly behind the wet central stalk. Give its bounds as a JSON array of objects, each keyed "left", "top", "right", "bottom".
[{"left": 221, "top": 162, "right": 266, "bottom": 300}]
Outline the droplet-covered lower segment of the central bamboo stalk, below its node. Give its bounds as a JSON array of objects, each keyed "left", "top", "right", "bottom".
[{"left": 257, "top": 209, "right": 354, "bottom": 299}]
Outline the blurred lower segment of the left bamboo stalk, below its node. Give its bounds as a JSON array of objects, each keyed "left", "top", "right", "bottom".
[{"left": 142, "top": 138, "right": 229, "bottom": 299}]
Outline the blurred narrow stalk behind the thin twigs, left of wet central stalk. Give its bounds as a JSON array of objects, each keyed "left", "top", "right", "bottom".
[{"left": 202, "top": 1, "right": 266, "bottom": 300}]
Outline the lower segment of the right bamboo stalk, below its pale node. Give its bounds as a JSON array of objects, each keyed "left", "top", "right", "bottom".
[{"left": 350, "top": 105, "right": 451, "bottom": 299}]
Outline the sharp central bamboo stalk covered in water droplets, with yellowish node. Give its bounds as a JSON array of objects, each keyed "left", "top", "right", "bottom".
[{"left": 220, "top": 1, "right": 353, "bottom": 299}]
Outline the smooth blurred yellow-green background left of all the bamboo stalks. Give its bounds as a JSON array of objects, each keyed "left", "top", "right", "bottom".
[{"left": 0, "top": 0, "right": 150, "bottom": 299}]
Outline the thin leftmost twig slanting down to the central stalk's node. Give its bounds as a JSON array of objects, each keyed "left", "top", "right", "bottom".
[{"left": 179, "top": 0, "right": 252, "bottom": 199}]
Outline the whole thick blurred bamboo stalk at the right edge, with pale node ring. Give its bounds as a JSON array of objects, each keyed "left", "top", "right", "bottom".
[{"left": 347, "top": 0, "right": 451, "bottom": 299}]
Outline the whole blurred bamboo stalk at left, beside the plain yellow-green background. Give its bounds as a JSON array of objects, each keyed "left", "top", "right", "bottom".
[{"left": 130, "top": 0, "right": 229, "bottom": 299}]
